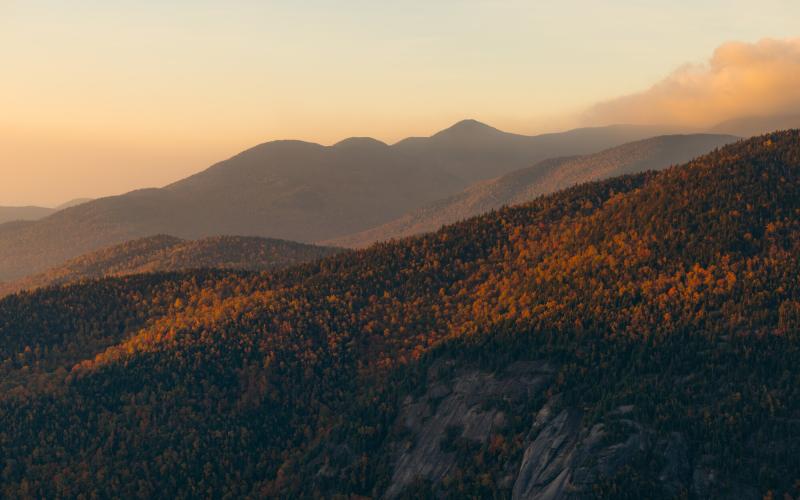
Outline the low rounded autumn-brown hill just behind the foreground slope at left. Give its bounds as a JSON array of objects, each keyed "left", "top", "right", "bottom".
[{"left": 0, "top": 235, "right": 340, "bottom": 296}]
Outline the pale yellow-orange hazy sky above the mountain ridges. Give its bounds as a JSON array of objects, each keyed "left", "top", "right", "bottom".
[{"left": 0, "top": 0, "right": 800, "bottom": 205}]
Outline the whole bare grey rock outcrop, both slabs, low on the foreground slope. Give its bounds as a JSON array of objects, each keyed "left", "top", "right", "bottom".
[{"left": 384, "top": 361, "right": 759, "bottom": 500}]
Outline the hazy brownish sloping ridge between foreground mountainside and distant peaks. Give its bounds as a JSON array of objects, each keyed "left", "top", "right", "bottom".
[{"left": 326, "top": 134, "right": 737, "bottom": 247}]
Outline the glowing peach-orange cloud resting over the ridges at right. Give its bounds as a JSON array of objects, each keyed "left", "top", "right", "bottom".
[{"left": 583, "top": 38, "right": 800, "bottom": 127}]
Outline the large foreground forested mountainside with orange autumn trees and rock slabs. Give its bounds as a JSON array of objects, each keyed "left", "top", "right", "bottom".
[{"left": 0, "top": 131, "right": 800, "bottom": 499}]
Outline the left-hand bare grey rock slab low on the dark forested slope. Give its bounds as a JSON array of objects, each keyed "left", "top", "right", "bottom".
[{"left": 385, "top": 362, "right": 553, "bottom": 498}]
